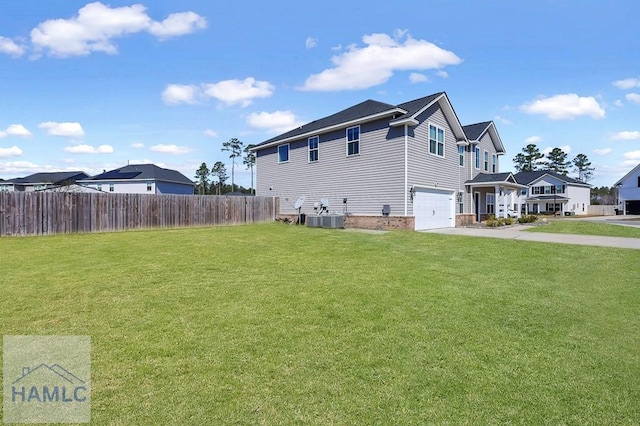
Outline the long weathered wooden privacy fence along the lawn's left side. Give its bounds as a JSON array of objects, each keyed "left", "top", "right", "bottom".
[{"left": 0, "top": 192, "right": 278, "bottom": 237}]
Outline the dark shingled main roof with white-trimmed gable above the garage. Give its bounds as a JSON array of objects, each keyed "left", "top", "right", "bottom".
[{"left": 252, "top": 92, "right": 467, "bottom": 150}]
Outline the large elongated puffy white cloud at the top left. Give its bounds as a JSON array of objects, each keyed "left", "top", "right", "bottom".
[{"left": 31, "top": 2, "right": 206, "bottom": 57}]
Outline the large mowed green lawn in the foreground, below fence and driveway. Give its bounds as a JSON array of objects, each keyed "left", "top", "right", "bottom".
[{"left": 0, "top": 224, "right": 640, "bottom": 425}]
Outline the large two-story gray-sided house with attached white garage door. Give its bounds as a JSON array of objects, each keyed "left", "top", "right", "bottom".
[{"left": 253, "top": 92, "right": 524, "bottom": 230}]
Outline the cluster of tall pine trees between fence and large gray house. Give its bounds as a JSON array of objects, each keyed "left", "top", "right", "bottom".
[{"left": 194, "top": 138, "right": 256, "bottom": 195}]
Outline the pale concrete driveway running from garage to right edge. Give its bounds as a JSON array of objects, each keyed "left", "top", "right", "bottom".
[{"left": 422, "top": 225, "right": 640, "bottom": 250}]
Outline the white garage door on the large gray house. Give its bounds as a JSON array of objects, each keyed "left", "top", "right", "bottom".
[{"left": 413, "top": 188, "right": 456, "bottom": 231}]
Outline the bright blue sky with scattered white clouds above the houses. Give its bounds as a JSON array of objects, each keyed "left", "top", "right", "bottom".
[{"left": 0, "top": 0, "right": 640, "bottom": 186}]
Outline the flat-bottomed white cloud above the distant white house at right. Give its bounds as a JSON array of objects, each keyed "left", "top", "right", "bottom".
[{"left": 520, "top": 93, "right": 605, "bottom": 120}]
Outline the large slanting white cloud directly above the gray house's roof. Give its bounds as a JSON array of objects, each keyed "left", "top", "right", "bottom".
[{"left": 300, "top": 31, "right": 462, "bottom": 91}]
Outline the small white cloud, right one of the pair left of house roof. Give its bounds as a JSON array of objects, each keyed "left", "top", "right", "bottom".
[{"left": 202, "top": 77, "right": 275, "bottom": 107}]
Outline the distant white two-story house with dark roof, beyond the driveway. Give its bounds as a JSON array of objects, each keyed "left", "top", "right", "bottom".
[{"left": 514, "top": 170, "right": 591, "bottom": 215}]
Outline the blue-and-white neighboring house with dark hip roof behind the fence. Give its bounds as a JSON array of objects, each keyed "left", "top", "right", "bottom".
[{"left": 78, "top": 164, "right": 195, "bottom": 195}]
